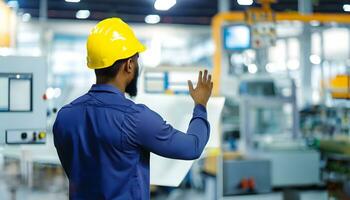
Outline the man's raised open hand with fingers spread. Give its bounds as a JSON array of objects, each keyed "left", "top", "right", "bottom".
[{"left": 188, "top": 70, "right": 213, "bottom": 107}]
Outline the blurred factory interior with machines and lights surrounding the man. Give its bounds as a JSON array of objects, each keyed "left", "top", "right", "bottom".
[{"left": 0, "top": 0, "right": 350, "bottom": 200}]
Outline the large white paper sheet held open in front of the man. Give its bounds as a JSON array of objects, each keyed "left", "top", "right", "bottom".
[{"left": 136, "top": 94, "right": 225, "bottom": 187}]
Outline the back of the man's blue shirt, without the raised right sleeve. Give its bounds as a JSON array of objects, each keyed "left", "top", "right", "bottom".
[{"left": 54, "top": 84, "right": 148, "bottom": 199}]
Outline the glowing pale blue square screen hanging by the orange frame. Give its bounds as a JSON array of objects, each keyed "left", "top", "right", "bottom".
[{"left": 223, "top": 25, "right": 251, "bottom": 51}]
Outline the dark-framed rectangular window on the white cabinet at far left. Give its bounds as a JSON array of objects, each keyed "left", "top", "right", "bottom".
[{"left": 0, "top": 73, "right": 32, "bottom": 112}]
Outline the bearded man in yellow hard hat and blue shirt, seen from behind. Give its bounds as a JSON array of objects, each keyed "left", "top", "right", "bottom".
[{"left": 53, "top": 18, "right": 213, "bottom": 200}]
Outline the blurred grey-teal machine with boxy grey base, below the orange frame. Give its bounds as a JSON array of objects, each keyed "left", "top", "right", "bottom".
[{"left": 240, "top": 76, "right": 320, "bottom": 187}]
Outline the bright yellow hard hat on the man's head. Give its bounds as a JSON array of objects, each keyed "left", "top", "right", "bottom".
[{"left": 86, "top": 18, "right": 146, "bottom": 69}]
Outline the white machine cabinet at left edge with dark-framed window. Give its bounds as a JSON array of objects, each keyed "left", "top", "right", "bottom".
[{"left": 0, "top": 56, "right": 47, "bottom": 145}]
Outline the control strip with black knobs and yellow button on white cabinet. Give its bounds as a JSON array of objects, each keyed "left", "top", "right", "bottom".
[{"left": 6, "top": 130, "right": 46, "bottom": 144}]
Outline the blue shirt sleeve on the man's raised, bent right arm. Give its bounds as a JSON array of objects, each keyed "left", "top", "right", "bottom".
[{"left": 124, "top": 105, "right": 210, "bottom": 160}]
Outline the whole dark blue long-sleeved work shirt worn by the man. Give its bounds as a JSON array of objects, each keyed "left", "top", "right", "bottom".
[{"left": 53, "top": 84, "right": 210, "bottom": 200}]
